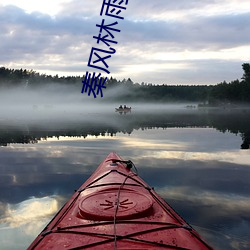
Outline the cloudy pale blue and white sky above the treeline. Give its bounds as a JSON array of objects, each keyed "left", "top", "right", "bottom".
[{"left": 0, "top": 0, "right": 250, "bottom": 84}]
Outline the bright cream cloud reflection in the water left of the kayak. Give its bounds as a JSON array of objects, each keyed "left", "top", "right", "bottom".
[{"left": 0, "top": 196, "right": 64, "bottom": 250}]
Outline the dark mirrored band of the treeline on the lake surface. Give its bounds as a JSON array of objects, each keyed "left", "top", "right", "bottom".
[{"left": 0, "top": 110, "right": 250, "bottom": 149}]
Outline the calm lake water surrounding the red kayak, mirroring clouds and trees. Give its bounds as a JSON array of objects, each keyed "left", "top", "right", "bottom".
[{"left": 0, "top": 105, "right": 250, "bottom": 250}]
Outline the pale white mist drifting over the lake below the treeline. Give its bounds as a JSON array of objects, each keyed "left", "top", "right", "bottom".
[{"left": 0, "top": 84, "right": 198, "bottom": 125}]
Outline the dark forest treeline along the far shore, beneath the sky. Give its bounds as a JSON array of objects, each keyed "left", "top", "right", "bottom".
[{"left": 0, "top": 63, "right": 250, "bottom": 105}]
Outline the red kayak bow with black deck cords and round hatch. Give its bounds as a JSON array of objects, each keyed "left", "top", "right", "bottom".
[{"left": 28, "top": 153, "right": 212, "bottom": 250}]
